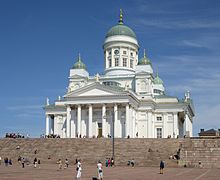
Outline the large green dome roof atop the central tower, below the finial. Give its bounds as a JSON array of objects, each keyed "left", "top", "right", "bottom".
[{"left": 105, "top": 24, "right": 137, "bottom": 39}]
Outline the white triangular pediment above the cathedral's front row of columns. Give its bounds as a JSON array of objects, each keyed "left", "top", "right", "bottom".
[{"left": 64, "top": 83, "right": 125, "bottom": 98}]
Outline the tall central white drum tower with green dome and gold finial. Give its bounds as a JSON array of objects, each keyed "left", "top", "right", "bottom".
[{"left": 103, "top": 10, "right": 139, "bottom": 76}]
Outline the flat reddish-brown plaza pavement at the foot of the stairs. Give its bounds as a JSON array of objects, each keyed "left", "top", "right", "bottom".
[{"left": 0, "top": 163, "right": 220, "bottom": 180}]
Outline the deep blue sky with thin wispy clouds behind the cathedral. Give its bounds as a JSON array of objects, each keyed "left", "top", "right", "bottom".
[{"left": 0, "top": 0, "right": 220, "bottom": 137}]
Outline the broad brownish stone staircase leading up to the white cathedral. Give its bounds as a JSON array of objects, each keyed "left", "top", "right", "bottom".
[{"left": 0, "top": 138, "right": 180, "bottom": 167}]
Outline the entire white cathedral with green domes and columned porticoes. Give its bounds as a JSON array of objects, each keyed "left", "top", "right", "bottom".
[{"left": 44, "top": 12, "right": 195, "bottom": 138}]
